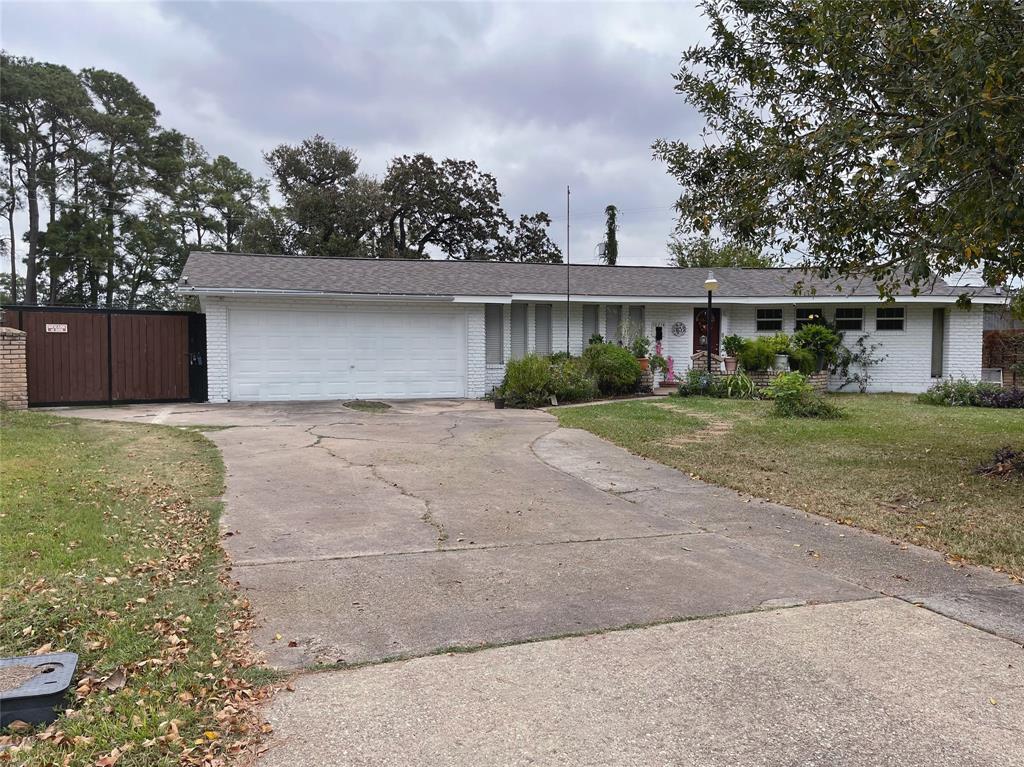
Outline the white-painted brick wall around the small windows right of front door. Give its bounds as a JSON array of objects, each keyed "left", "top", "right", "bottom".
[{"left": 728, "top": 301, "right": 984, "bottom": 392}]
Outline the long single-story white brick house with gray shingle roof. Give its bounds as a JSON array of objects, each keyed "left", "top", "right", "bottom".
[{"left": 178, "top": 252, "right": 1006, "bottom": 402}]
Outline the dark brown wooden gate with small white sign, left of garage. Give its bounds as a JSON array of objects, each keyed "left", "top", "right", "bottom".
[{"left": 3, "top": 306, "right": 206, "bottom": 406}]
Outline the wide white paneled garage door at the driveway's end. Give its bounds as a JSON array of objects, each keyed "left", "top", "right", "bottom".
[{"left": 227, "top": 307, "right": 466, "bottom": 400}]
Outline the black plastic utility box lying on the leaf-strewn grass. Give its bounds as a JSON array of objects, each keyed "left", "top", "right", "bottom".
[{"left": 0, "top": 652, "right": 78, "bottom": 727}]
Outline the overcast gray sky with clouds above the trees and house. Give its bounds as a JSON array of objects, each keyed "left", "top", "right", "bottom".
[{"left": 0, "top": 0, "right": 707, "bottom": 264}]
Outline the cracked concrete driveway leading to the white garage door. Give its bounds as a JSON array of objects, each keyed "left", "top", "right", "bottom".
[{"left": 59, "top": 401, "right": 1024, "bottom": 765}]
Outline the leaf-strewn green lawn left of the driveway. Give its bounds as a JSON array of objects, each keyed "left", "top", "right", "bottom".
[{"left": 0, "top": 413, "right": 272, "bottom": 765}]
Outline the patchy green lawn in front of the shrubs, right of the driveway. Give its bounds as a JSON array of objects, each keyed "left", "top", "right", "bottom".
[{"left": 554, "top": 394, "right": 1024, "bottom": 578}]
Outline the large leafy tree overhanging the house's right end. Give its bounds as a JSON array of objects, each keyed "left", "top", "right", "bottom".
[{"left": 654, "top": 0, "right": 1024, "bottom": 307}]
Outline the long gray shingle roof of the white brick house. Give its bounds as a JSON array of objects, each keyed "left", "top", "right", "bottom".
[{"left": 179, "top": 252, "right": 994, "bottom": 298}]
